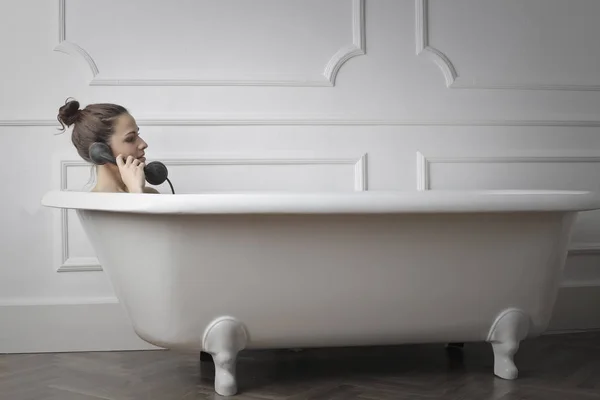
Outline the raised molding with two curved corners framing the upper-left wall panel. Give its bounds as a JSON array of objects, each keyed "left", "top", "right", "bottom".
[{"left": 54, "top": 0, "right": 366, "bottom": 87}]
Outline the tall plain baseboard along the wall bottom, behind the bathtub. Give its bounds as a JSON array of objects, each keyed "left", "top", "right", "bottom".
[{"left": 0, "top": 286, "right": 600, "bottom": 353}]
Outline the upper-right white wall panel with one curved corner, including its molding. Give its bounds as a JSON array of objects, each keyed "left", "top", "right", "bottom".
[{"left": 417, "top": 0, "right": 600, "bottom": 91}]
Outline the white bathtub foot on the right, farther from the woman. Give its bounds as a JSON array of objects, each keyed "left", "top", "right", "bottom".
[{"left": 487, "top": 308, "right": 529, "bottom": 379}]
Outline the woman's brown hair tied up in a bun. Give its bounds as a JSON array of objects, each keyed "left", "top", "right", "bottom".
[{"left": 57, "top": 99, "right": 128, "bottom": 162}]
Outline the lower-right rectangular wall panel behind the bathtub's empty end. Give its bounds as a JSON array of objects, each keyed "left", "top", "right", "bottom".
[{"left": 417, "top": 152, "right": 600, "bottom": 286}]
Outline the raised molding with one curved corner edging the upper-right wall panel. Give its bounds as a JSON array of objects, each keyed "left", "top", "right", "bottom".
[{"left": 415, "top": 0, "right": 600, "bottom": 91}]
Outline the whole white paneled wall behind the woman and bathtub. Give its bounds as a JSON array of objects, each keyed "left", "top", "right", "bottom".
[{"left": 0, "top": 0, "right": 600, "bottom": 352}]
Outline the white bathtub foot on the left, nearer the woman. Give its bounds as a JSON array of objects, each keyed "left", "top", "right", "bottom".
[{"left": 203, "top": 317, "right": 248, "bottom": 396}]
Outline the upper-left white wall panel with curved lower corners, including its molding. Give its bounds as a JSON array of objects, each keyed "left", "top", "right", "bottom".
[{"left": 59, "top": 0, "right": 364, "bottom": 86}]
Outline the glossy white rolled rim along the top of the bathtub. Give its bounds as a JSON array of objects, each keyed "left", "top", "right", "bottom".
[{"left": 41, "top": 190, "right": 600, "bottom": 214}]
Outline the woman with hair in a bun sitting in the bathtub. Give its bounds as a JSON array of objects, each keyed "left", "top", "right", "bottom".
[{"left": 57, "top": 100, "right": 159, "bottom": 193}]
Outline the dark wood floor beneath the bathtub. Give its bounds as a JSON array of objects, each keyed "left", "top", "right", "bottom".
[{"left": 0, "top": 333, "right": 600, "bottom": 400}]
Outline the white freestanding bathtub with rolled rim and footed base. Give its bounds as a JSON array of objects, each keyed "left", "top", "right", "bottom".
[{"left": 42, "top": 191, "right": 600, "bottom": 396}]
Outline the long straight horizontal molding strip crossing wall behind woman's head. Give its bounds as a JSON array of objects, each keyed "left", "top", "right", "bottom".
[{"left": 5, "top": 115, "right": 600, "bottom": 128}]
